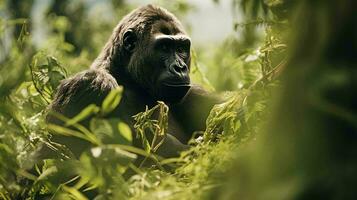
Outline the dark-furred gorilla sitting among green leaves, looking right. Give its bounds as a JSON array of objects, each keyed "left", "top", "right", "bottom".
[{"left": 48, "top": 5, "right": 218, "bottom": 157}]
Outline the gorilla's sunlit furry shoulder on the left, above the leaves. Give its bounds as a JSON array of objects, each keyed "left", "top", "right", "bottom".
[{"left": 51, "top": 69, "right": 118, "bottom": 114}]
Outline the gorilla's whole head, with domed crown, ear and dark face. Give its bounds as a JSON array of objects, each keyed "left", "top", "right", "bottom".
[{"left": 94, "top": 5, "right": 191, "bottom": 102}]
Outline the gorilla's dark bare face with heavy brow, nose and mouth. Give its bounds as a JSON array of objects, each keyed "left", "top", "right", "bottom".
[{"left": 124, "top": 21, "right": 191, "bottom": 102}]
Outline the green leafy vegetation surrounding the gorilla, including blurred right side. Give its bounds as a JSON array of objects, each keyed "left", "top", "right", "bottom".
[{"left": 0, "top": 0, "right": 357, "bottom": 199}]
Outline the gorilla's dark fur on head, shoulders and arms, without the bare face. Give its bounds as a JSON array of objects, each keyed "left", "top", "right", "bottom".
[{"left": 48, "top": 5, "right": 218, "bottom": 157}]
